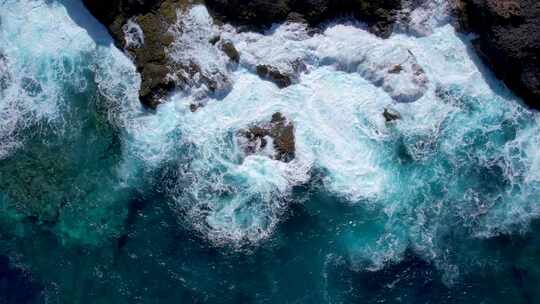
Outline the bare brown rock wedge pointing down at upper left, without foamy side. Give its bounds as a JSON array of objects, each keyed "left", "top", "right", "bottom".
[{"left": 83, "top": 0, "right": 195, "bottom": 109}]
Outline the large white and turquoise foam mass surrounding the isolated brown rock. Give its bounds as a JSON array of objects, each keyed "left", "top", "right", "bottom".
[{"left": 123, "top": 3, "right": 538, "bottom": 274}]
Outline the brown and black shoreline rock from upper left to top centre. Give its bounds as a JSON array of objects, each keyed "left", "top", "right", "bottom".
[{"left": 83, "top": 0, "right": 400, "bottom": 110}]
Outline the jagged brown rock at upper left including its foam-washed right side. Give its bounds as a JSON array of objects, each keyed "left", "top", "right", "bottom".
[{"left": 84, "top": 0, "right": 240, "bottom": 109}]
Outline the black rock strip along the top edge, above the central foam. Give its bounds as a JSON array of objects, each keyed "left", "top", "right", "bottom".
[{"left": 206, "top": 0, "right": 401, "bottom": 37}]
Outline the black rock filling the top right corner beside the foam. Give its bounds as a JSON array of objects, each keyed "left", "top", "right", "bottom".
[{"left": 454, "top": 0, "right": 540, "bottom": 109}]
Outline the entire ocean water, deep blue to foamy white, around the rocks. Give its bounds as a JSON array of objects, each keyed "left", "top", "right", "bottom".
[{"left": 0, "top": 0, "right": 540, "bottom": 303}]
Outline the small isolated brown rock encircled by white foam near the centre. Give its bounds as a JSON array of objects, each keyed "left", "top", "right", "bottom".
[{"left": 238, "top": 112, "right": 295, "bottom": 162}]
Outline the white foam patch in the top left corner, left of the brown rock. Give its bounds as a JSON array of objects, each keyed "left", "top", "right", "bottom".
[{"left": 0, "top": 1, "right": 92, "bottom": 158}]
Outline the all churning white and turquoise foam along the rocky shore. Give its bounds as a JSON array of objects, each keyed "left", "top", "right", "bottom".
[{"left": 0, "top": 1, "right": 540, "bottom": 281}]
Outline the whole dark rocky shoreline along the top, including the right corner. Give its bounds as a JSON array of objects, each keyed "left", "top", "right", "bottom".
[{"left": 84, "top": 0, "right": 540, "bottom": 110}]
